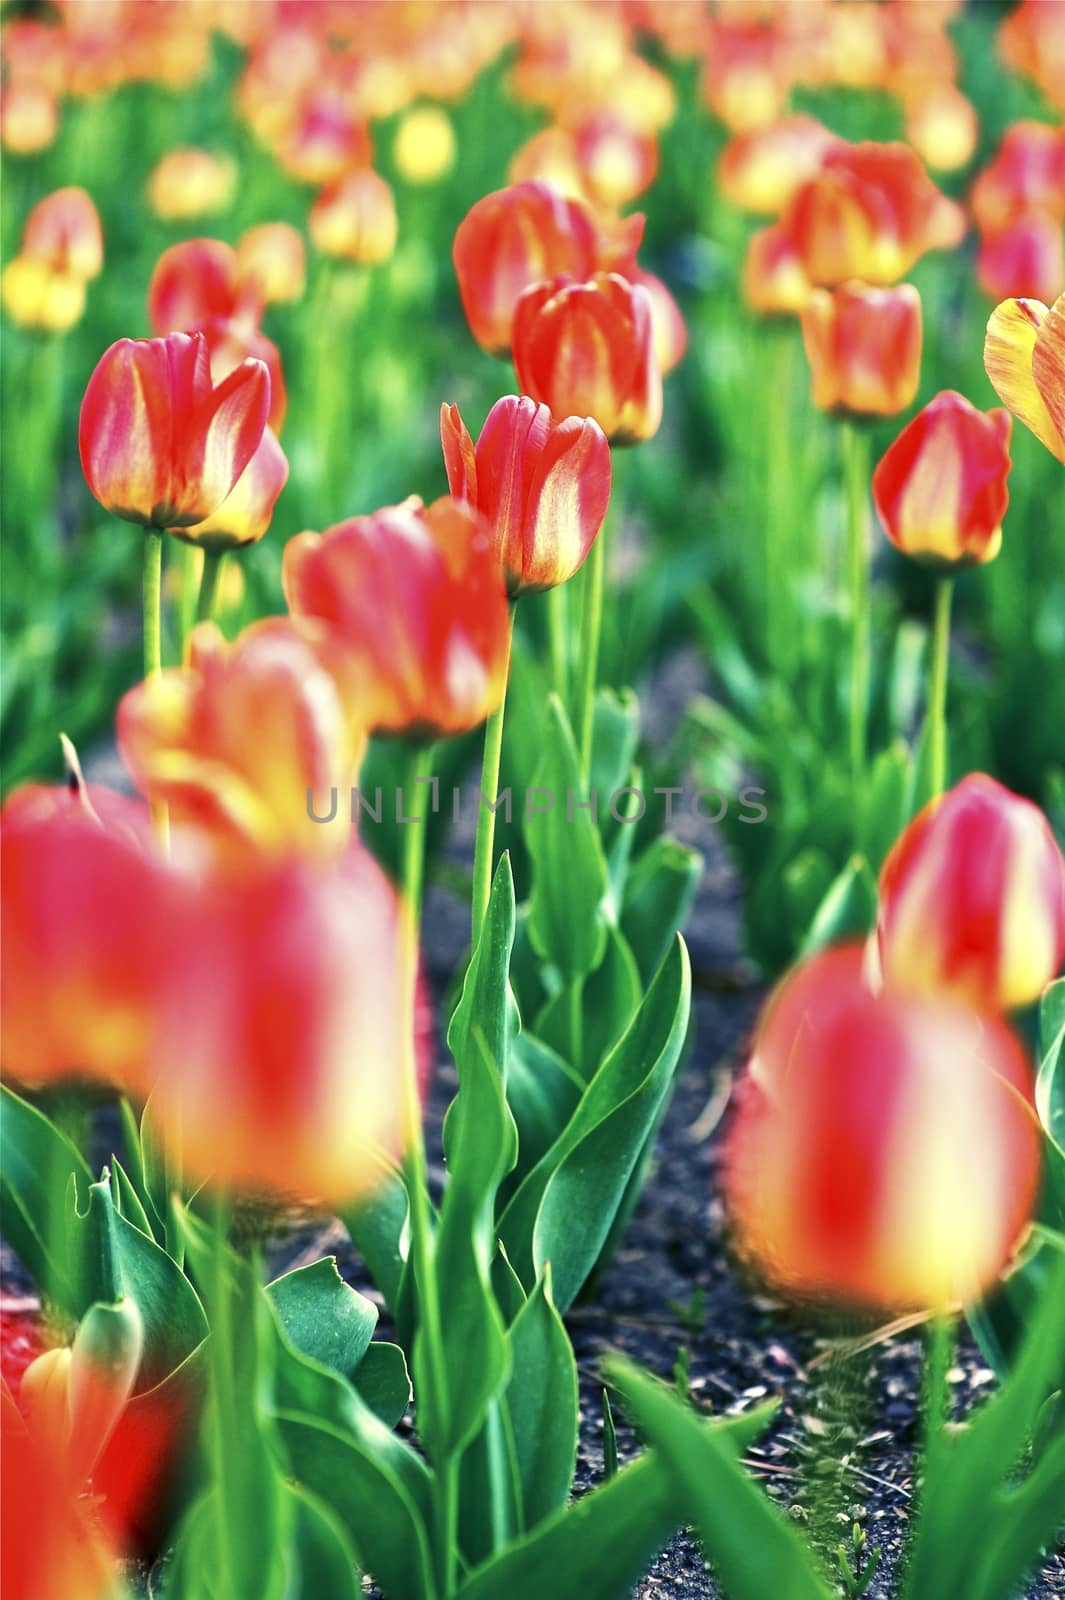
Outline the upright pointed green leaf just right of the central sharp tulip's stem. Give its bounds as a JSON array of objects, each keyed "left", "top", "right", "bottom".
[{"left": 525, "top": 694, "right": 606, "bottom": 982}]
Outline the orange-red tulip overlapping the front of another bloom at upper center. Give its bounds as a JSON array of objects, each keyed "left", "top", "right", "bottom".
[{"left": 513, "top": 272, "right": 662, "bottom": 445}]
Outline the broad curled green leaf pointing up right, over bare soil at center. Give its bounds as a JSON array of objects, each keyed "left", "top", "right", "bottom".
[{"left": 499, "top": 938, "right": 691, "bottom": 1314}]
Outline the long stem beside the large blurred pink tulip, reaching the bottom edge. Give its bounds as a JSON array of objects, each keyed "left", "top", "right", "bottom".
[{"left": 400, "top": 746, "right": 457, "bottom": 1600}]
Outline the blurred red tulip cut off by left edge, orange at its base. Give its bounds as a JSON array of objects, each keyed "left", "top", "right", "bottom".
[{"left": 0, "top": 786, "right": 170, "bottom": 1090}]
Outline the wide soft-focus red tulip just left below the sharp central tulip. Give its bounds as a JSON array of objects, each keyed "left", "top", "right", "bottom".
[{"left": 283, "top": 498, "right": 510, "bottom": 739}]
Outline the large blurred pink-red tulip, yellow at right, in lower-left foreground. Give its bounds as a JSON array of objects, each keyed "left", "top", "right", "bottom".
[{"left": 154, "top": 845, "right": 413, "bottom": 1202}]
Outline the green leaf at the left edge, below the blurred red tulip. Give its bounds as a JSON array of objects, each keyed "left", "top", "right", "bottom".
[{"left": 0, "top": 1085, "right": 92, "bottom": 1317}]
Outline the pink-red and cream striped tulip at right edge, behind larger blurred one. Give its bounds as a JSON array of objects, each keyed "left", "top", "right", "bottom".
[{"left": 878, "top": 773, "right": 1065, "bottom": 1011}]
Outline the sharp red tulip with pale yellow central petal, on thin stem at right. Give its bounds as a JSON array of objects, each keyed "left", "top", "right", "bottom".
[{"left": 873, "top": 389, "right": 1012, "bottom": 566}]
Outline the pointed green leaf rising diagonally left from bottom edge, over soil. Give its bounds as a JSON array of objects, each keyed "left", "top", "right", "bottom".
[{"left": 606, "top": 1357, "right": 833, "bottom": 1600}]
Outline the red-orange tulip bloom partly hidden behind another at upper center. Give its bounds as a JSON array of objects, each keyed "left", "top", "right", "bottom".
[{"left": 453, "top": 181, "right": 598, "bottom": 355}]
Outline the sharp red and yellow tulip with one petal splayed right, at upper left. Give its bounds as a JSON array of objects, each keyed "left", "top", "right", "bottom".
[{"left": 78, "top": 333, "right": 270, "bottom": 528}]
